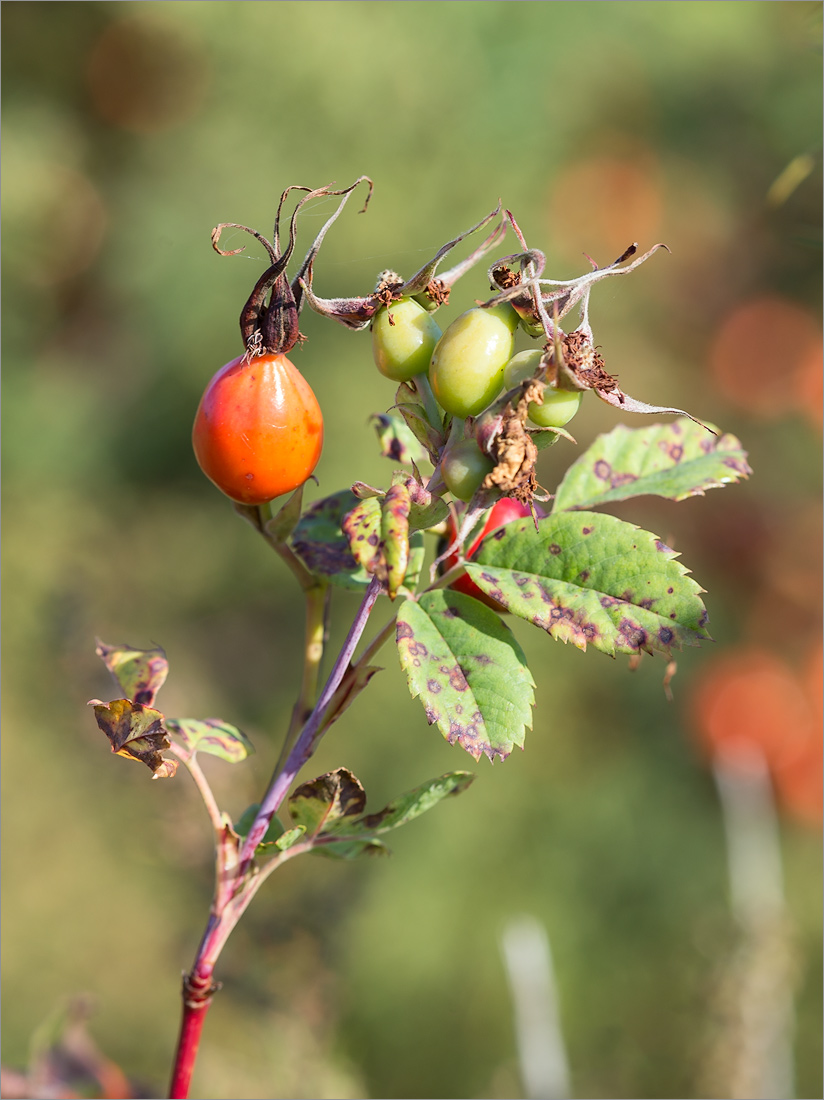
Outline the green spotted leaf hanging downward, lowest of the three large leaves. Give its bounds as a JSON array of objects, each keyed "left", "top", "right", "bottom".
[{"left": 396, "top": 590, "right": 535, "bottom": 760}]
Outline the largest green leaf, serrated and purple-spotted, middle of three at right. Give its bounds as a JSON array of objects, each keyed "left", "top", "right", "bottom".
[{"left": 466, "top": 512, "right": 710, "bottom": 656}]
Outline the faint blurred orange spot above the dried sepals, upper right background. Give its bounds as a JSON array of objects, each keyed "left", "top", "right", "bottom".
[{"left": 550, "top": 155, "right": 662, "bottom": 265}]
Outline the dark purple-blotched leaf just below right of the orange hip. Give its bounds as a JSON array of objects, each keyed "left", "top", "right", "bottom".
[{"left": 290, "top": 488, "right": 370, "bottom": 590}]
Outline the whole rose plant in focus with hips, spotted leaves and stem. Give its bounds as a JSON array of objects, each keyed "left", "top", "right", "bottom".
[{"left": 91, "top": 177, "right": 750, "bottom": 1097}]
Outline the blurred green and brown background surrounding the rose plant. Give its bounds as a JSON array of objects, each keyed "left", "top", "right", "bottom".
[{"left": 2, "top": 0, "right": 822, "bottom": 1098}]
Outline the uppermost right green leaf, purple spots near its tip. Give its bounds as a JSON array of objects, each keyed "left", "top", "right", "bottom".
[{"left": 552, "top": 418, "right": 752, "bottom": 513}]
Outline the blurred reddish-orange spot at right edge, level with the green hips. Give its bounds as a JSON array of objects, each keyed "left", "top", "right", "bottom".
[{"left": 710, "top": 296, "right": 822, "bottom": 422}]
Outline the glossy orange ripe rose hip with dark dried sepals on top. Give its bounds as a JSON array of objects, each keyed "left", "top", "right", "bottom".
[{"left": 191, "top": 353, "right": 323, "bottom": 505}]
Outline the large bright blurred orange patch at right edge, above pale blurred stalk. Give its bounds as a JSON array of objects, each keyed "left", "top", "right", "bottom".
[{"left": 692, "top": 649, "right": 822, "bottom": 822}]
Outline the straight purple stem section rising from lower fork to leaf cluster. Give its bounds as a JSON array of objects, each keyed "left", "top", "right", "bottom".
[{"left": 238, "top": 576, "right": 381, "bottom": 866}]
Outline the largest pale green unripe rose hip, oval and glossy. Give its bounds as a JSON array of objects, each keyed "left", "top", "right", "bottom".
[{"left": 429, "top": 304, "right": 518, "bottom": 417}]
